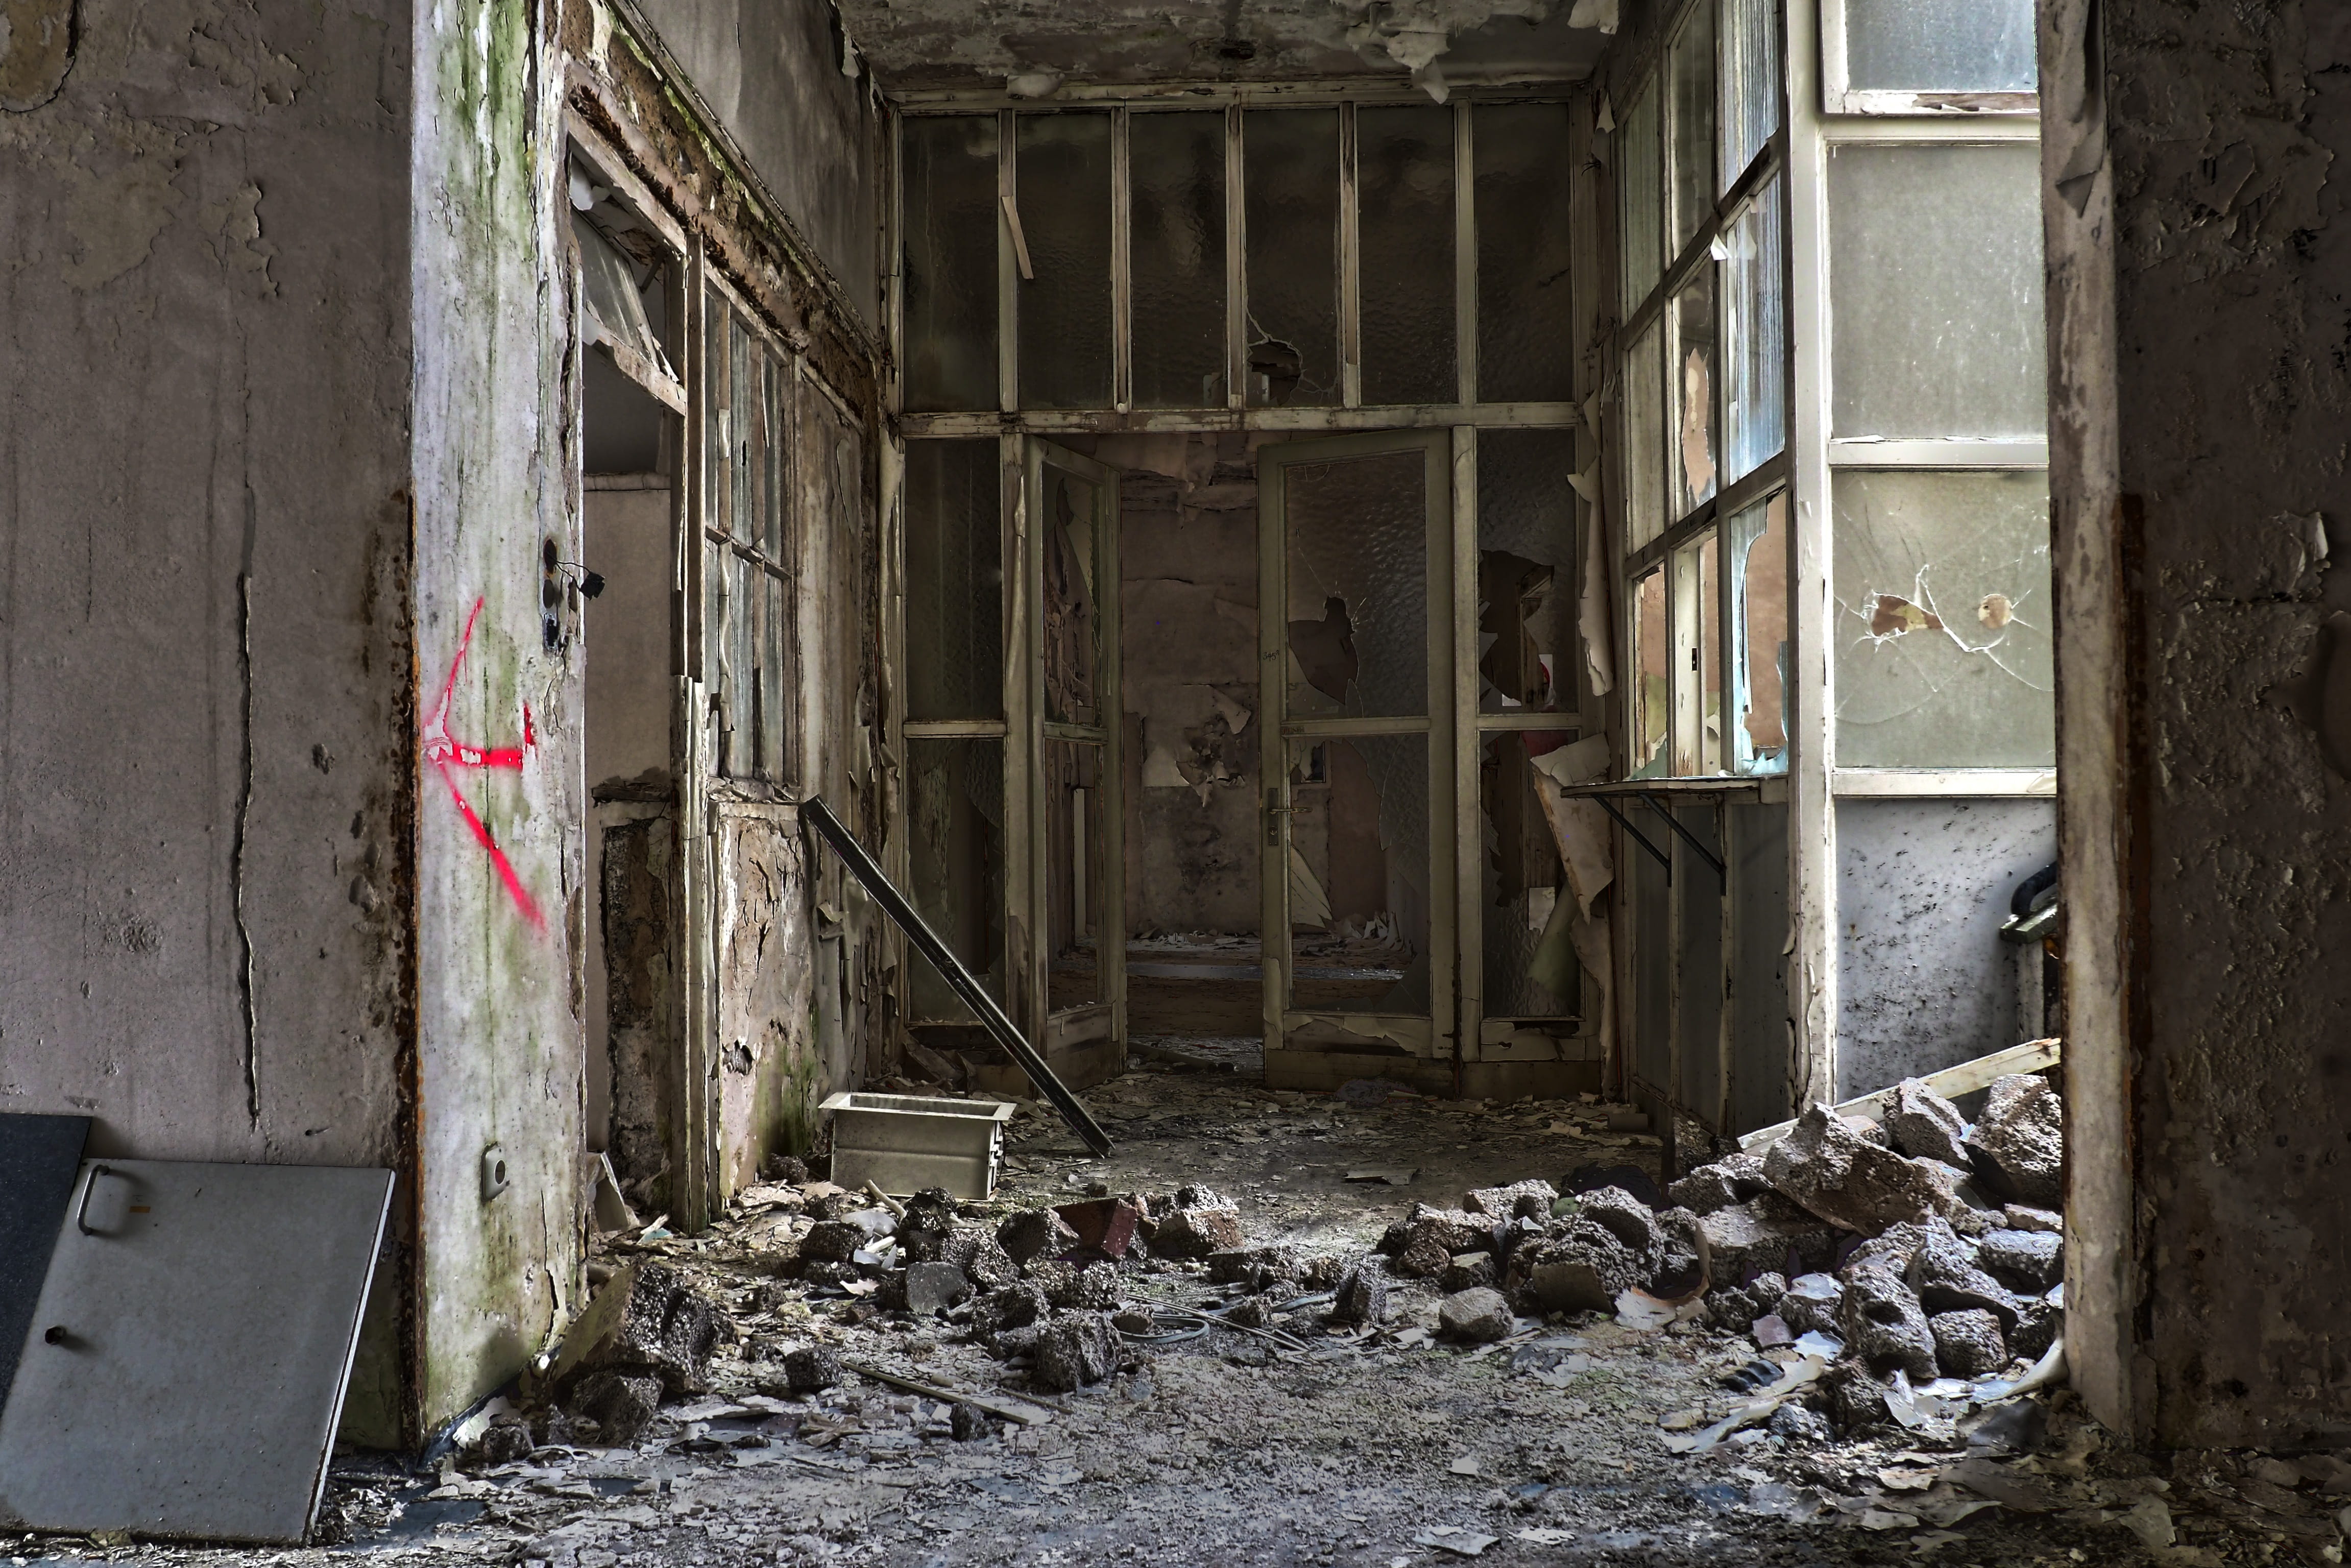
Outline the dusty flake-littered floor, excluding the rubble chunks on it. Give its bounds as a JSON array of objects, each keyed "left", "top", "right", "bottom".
[{"left": 22, "top": 1010, "right": 2339, "bottom": 1568}]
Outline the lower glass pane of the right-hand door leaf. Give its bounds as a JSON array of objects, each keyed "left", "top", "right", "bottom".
[{"left": 1289, "top": 736, "right": 1429, "bottom": 1016}]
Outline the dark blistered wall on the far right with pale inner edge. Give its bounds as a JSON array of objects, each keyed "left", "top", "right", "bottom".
[{"left": 2041, "top": 0, "right": 2351, "bottom": 1448}]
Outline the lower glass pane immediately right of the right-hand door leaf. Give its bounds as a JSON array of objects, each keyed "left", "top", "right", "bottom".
[{"left": 1479, "top": 729, "right": 1582, "bottom": 1018}]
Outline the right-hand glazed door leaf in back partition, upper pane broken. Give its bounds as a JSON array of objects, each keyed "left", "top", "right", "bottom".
[{"left": 1258, "top": 430, "right": 1458, "bottom": 1086}]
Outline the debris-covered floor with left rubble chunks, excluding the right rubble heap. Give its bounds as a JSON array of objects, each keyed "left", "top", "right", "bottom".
[{"left": 36, "top": 1063, "right": 2351, "bottom": 1568}]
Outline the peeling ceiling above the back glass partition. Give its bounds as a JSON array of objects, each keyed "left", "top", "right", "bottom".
[{"left": 839, "top": 0, "right": 1615, "bottom": 101}]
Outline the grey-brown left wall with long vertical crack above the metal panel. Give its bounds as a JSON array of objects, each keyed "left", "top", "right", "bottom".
[{"left": 0, "top": 0, "right": 419, "bottom": 1441}]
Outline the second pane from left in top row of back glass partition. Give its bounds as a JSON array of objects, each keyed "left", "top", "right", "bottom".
[{"left": 1013, "top": 113, "right": 1112, "bottom": 409}]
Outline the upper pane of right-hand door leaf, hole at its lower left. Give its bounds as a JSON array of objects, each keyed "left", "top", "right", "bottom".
[{"left": 1283, "top": 451, "right": 1429, "bottom": 717}]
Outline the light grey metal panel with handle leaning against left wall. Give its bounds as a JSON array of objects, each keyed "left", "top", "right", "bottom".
[{"left": 0, "top": 1159, "right": 393, "bottom": 1542}]
